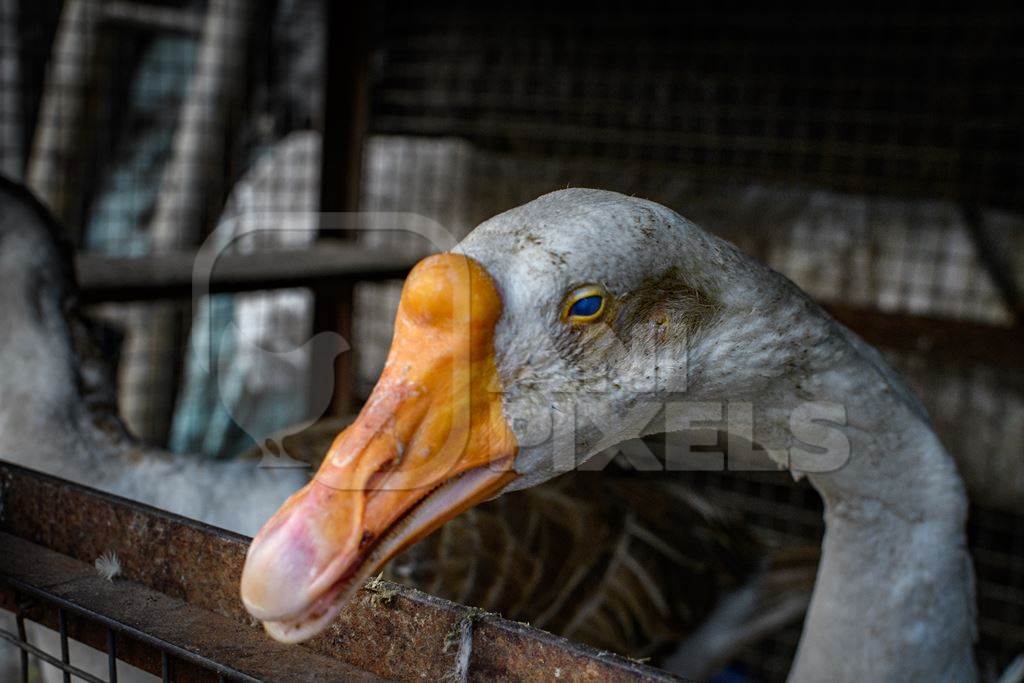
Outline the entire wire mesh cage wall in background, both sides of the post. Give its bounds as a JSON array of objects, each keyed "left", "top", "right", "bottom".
[{"left": 0, "top": 0, "right": 1024, "bottom": 680}]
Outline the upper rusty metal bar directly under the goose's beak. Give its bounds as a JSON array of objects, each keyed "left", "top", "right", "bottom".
[{"left": 0, "top": 463, "right": 676, "bottom": 681}]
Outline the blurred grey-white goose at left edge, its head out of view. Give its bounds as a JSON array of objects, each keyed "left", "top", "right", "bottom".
[{"left": 0, "top": 176, "right": 309, "bottom": 681}]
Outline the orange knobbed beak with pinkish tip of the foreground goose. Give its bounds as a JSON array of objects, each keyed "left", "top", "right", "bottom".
[{"left": 235, "top": 254, "right": 517, "bottom": 642}]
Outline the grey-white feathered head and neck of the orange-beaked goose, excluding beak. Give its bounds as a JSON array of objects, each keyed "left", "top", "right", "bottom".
[{"left": 457, "top": 189, "right": 977, "bottom": 681}]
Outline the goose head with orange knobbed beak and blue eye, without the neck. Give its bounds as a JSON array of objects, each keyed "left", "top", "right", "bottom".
[{"left": 242, "top": 185, "right": 847, "bottom": 642}]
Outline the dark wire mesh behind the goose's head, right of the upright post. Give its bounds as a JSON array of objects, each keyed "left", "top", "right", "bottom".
[{"left": 357, "top": 3, "right": 1024, "bottom": 679}]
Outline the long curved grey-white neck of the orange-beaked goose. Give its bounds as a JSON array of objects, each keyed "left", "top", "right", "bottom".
[{"left": 668, "top": 270, "right": 975, "bottom": 681}]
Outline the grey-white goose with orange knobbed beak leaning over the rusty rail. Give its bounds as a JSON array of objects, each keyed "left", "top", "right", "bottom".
[{"left": 240, "top": 188, "right": 977, "bottom": 681}]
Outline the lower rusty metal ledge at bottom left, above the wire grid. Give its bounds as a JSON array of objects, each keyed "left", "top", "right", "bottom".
[{"left": 0, "top": 532, "right": 374, "bottom": 683}]
